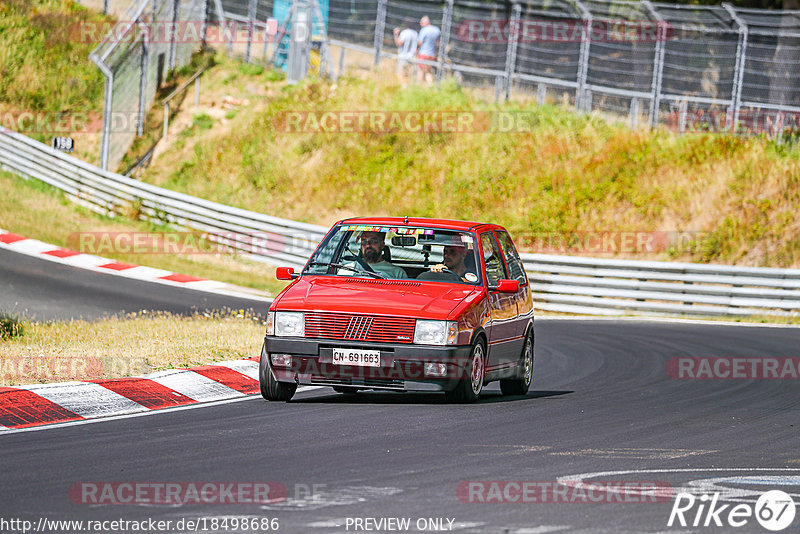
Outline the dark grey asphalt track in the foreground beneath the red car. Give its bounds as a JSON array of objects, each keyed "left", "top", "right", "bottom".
[{"left": 0, "top": 320, "right": 800, "bottom": 534}]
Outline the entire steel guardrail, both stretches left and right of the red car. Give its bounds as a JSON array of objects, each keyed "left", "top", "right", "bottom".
[{"left": 0, "top": 127, "right": 800, "bottom": 316}]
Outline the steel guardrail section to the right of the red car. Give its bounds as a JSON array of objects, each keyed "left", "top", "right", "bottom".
[{"left": 521, "top": 254, "right": 800, "bottom": 316}]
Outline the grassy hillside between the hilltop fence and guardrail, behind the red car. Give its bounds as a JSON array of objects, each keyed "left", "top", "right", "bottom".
[{"left": 144, "top": 62, "right": 800, "bottom": 266}]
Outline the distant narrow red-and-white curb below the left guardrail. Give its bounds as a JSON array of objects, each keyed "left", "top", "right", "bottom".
[{"left": 0, "top": 228, "right": 272, "bottom": 302}]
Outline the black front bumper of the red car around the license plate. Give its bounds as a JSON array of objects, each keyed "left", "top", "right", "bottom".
[{"left": 261, "top": 336, "right": 472, "bottom": 391}]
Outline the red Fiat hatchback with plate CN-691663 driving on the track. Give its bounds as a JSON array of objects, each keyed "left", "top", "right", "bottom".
[{"left": 259, "top": 217, "right": 533, "bottom": 402}]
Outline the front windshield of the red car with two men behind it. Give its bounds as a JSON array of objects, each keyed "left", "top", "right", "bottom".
[{"left": 303, "top": 224, "right": 481, "bottom": 285}]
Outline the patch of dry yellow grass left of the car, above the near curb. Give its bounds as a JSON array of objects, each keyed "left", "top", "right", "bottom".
[{"left": 0, "top": 311, "right": 264, "bottom": 385}]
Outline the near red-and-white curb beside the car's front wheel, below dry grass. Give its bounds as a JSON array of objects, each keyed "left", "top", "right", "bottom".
[{"left": 0, "top": 360, "right": 318, "bottom": 435}]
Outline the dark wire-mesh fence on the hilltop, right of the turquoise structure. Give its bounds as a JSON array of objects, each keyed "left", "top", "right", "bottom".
[{"left": 214, "top": 0, "right": 800, "bottom": 137}]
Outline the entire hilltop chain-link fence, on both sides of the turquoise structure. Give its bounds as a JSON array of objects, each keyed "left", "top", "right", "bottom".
[{"left": 91, "top": 0, "right": 800, "bottom": 169}]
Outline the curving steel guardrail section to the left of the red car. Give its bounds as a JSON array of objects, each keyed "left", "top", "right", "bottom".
[{"left": 0, "top": 128, "right": 327, "bottom": 267}]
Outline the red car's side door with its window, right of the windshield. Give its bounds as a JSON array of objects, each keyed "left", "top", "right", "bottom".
[{"left": 481, "top": 231, "right": 519, "bottom": 373}]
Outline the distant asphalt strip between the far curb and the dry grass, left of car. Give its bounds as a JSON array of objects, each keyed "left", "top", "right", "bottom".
[{"left": 0, "top": 249, "right": 267, "bottom": 321}]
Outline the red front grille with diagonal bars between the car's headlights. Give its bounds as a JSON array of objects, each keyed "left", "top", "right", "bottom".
[{"left": 306, "top": 312, "right": 415, "bottom": 343}]
